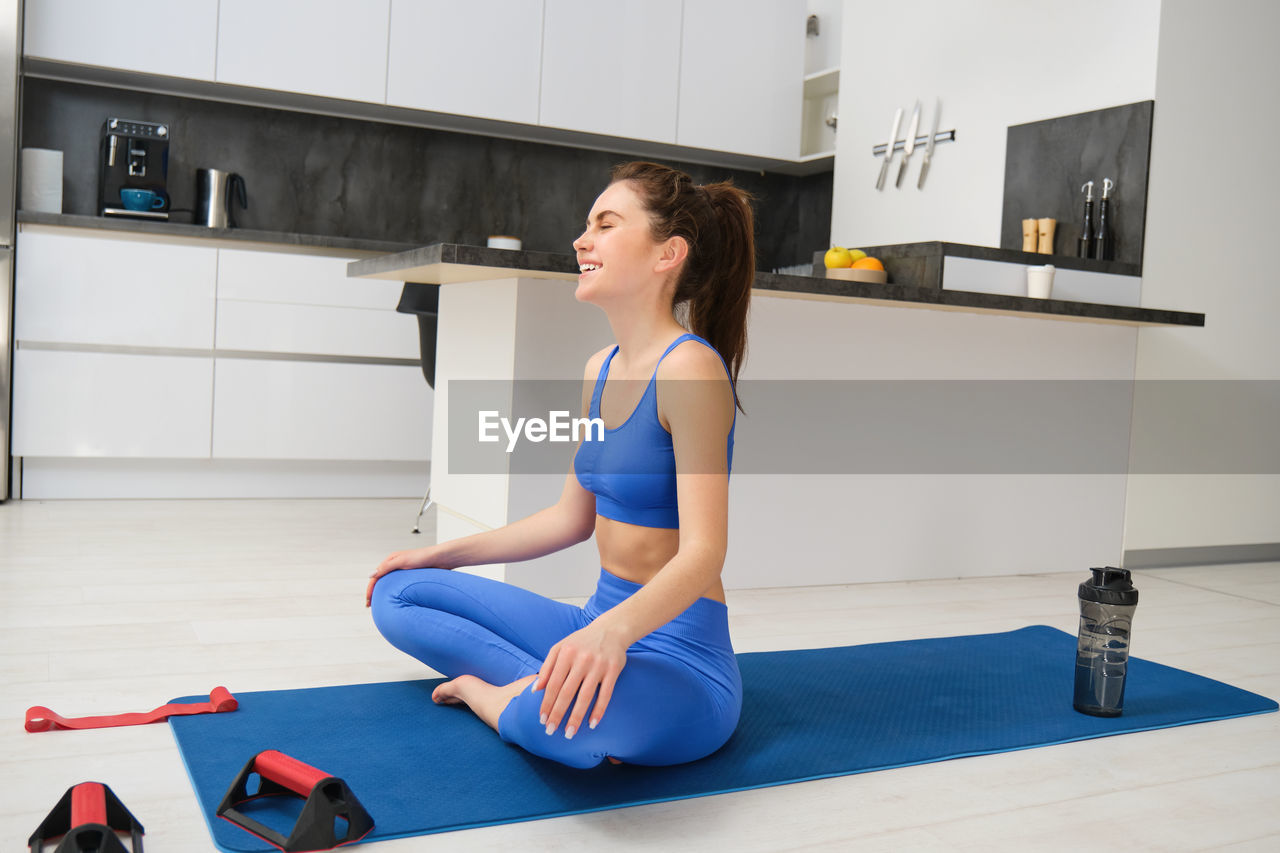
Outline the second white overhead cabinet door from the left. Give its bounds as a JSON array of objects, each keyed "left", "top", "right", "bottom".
[{"left": 218, "top": 0, "right": 390, "bottom": 104}]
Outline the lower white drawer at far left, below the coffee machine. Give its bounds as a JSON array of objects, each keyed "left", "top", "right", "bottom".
[{"left": 13, "top": 345, "right": 214, "bottom": 459}]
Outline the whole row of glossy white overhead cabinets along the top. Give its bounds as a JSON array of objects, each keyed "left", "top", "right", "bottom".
[{"left": 24, "top": 0, "right": 812, "bottom": 163}]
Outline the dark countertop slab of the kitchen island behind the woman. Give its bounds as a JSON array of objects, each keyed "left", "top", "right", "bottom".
[{"left": 347, "top": 243, "right": 1204, "bottom": 327}]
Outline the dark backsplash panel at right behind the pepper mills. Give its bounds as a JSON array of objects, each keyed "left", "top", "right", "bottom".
[{"left": 1000, "top": 101, "right": 1155, "bottom": 268}]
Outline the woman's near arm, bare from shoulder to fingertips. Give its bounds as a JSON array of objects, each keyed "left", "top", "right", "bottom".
[{"left": 534, "top": 346, "right": 733, "bottom": 735}]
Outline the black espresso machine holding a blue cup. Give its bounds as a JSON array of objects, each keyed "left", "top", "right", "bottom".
[{"left": 97, "top": 118, "right": 169, "bottom": 220}]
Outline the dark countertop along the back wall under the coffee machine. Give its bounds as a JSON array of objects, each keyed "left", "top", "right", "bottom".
[{"left": 18, "top": 210, "right": 411, "bottom": 254}]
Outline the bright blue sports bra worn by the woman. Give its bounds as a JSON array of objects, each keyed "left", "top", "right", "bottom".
[{"left": 573, "top": 333, "right": 737, "bottom": 529}]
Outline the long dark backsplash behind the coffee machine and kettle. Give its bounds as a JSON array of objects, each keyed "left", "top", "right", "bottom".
[{"left": 22, "top": 78, "right": 832, "bottom": 270}]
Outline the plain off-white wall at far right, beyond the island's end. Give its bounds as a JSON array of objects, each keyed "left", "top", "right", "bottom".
[{"left": 1125, "top": 0, "right": 1280, "bottom": 549}]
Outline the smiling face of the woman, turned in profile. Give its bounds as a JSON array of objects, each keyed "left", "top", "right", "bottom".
[{"left": 573, "top": 181, "right": 663, "bottom": 302}]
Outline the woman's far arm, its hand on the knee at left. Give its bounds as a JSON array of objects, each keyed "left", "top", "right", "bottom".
[{"left": 365, "top": 350, "right": 608, "bottom": 605}]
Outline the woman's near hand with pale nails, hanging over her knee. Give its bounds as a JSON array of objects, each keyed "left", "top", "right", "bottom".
[{"left": 534, "top": 620, "right": 630, "bottom": 738}]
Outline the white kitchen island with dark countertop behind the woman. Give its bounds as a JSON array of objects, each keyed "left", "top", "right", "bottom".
[{"left": 348, "top": 243, "right": 1204, "bottom": 596}]
